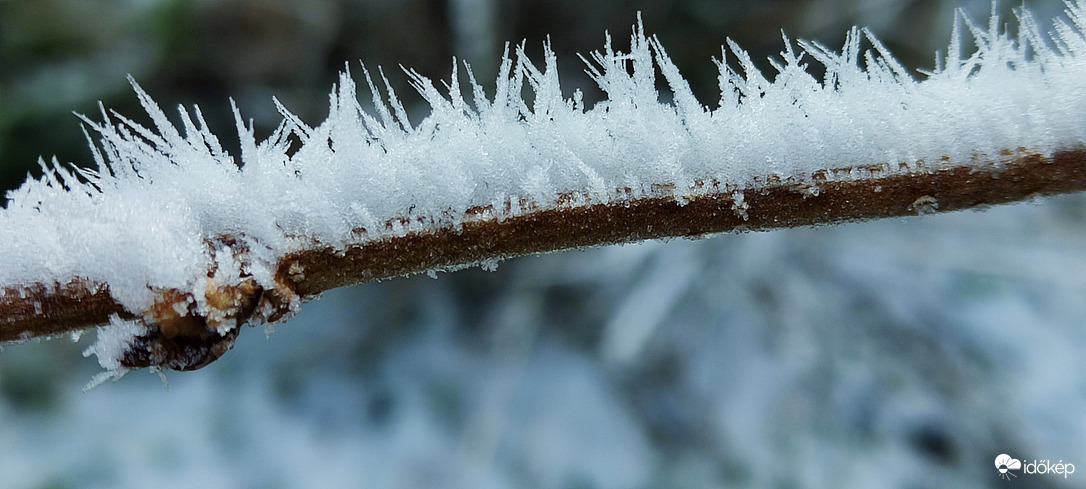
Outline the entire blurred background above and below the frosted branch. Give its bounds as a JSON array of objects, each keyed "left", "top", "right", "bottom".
[{"left": 0, "top": 0, "right": 1086, "bottom": 489}]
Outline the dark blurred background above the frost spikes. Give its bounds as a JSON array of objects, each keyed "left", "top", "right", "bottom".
[{"left": 0, "top": 0, "right": 1009, "bottom": 206}]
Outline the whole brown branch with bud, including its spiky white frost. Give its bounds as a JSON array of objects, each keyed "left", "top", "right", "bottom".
[{"left": 0, "top": 0, "right": 1086, "bottom": 378}]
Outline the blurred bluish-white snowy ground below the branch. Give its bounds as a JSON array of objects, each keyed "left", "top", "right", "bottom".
[{"left": 0, "top": 196, "right": 1086, "bottom": 488}]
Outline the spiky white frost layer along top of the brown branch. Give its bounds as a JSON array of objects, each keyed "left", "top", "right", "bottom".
[{"left": 0, "top": 1, "right": 1086, "bottom": 311}]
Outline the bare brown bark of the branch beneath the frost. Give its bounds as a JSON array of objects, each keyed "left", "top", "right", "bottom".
[{"left": 0, "top": 148, "right": 1086, "bottom": 341}]
